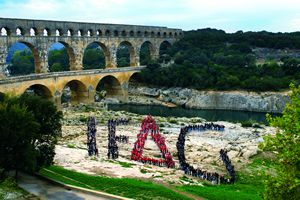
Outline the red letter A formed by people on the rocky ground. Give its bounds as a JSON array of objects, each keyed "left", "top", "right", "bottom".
[{"left": 131, "top": 115, "right": 175, "bottom": 168}]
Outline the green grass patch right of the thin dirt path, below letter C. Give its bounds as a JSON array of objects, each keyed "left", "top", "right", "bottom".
[{"left": 177, "top": 155, "right": 274, "bottom": 200}]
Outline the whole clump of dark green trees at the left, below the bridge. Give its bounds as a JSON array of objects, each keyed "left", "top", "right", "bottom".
[{"left": 0, "top": 95, "right": 62, "bottom": 177}]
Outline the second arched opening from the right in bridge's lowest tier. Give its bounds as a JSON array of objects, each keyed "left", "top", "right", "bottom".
[{"left": 61, "top": 80, "right": 88, "bottom": 105}]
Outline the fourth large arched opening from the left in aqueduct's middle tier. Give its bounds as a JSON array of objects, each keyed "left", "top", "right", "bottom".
[{"left": 117, "top": 41, "right": 136, "bottom": 67}]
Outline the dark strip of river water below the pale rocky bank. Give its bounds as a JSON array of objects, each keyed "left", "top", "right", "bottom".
[{"left": 108, "top": 104, "right": 279, "bottom": 123}]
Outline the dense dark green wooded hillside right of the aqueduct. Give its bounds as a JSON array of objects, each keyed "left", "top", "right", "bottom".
[{"left": 142, "top": 29, "right": 300, "bottom": 91}]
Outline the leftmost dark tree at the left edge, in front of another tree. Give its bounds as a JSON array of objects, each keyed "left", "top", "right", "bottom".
[{"left": 0, "top": 102, "right": 40, "bottom": 178}]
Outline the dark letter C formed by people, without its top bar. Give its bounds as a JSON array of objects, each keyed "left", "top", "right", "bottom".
[{"left": 176, "top": 125, "right": 235, "bottom": 184}]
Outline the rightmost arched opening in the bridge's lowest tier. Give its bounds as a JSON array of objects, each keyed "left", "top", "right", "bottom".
[{"left": 95, "top": 75, "right": 124, "bottom": 101}]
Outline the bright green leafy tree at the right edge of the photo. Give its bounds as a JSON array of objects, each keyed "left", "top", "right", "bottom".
[{"left": 260, "top": 85, "right": 300, "bottom": 200}]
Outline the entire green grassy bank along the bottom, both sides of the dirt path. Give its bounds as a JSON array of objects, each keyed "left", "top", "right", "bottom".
[{"left": 40, "top": 154, "right": 273, "bottom": 200}]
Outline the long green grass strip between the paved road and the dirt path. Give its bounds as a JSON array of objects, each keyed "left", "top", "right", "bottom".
[{"left": 40, "top": 166, "right": 189, "bottom": 200}]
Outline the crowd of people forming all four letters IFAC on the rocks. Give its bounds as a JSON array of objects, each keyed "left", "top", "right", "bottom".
[{"left": 87, "top": 114, "right": 236, "bottom": 184}]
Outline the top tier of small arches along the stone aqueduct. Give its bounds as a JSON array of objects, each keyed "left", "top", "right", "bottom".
[{"left": 0, "top": 18, "right": 183, "bottom": 38}]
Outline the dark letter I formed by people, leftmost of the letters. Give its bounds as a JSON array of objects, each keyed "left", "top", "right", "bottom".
[{"left": 86, "top": 117, "right": 98, "bottom": 156}]
